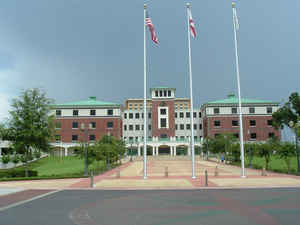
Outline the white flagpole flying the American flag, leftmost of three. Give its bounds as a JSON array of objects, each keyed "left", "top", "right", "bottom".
[{"left": 144, "top": 4, "right": 147, "bottom": 179}]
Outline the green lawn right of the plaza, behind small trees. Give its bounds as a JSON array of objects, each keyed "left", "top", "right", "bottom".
[{"left": 245, "top": 156, "right": 297, "bottom": 174}]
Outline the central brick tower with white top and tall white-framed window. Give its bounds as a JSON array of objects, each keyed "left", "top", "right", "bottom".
[{"left": 150, "top": 87, "right": 176, "bottom": 138}]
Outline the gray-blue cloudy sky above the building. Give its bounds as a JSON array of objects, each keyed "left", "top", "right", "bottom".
[{"left": 0, "top": 0, "right": 300, "bottom": 132}]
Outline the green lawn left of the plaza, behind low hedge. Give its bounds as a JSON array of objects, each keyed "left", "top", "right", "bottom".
[{"left": 31, "top": 156, "right": 104, "bottom": 176}]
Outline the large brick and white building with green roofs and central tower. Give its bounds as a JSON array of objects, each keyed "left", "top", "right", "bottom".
[{"left": 49, "top": 87, "right": 280, "bottom": 155}]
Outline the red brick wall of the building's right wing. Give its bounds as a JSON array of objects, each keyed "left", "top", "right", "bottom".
[{"left": 204, "top": 116, "right": 281, "bottom": 141}]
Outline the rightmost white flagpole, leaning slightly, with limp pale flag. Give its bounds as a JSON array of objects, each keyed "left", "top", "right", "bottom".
[{"left": 232, "top": 2, "right": 246, "bottom": 178}]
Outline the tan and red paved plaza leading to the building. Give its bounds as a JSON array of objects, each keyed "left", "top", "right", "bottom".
[{"left": 0, "top": 157, "right": 300, "bottom": 193}]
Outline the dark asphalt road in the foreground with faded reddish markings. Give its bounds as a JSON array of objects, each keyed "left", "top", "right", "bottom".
[{"left": 0, "top": 188, "right": 300, "bottom": 225}]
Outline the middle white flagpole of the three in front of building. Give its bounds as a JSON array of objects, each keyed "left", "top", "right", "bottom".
[{"left": 186, "top": 3, "right": 196, "bottom": 179}]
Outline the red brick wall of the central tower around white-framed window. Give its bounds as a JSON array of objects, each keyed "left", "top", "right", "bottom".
[{"left": 152, "top": 100, "right": 175, "bottom": 138}]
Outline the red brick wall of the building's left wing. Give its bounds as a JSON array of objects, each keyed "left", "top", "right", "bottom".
[{"left": 56, "top": 118, "right": 122, "bottom": 142}]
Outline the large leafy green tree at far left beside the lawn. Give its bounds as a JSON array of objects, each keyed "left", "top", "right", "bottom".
[{"left": 0, "top": 88, "right": 54, "bottom": 176}]
